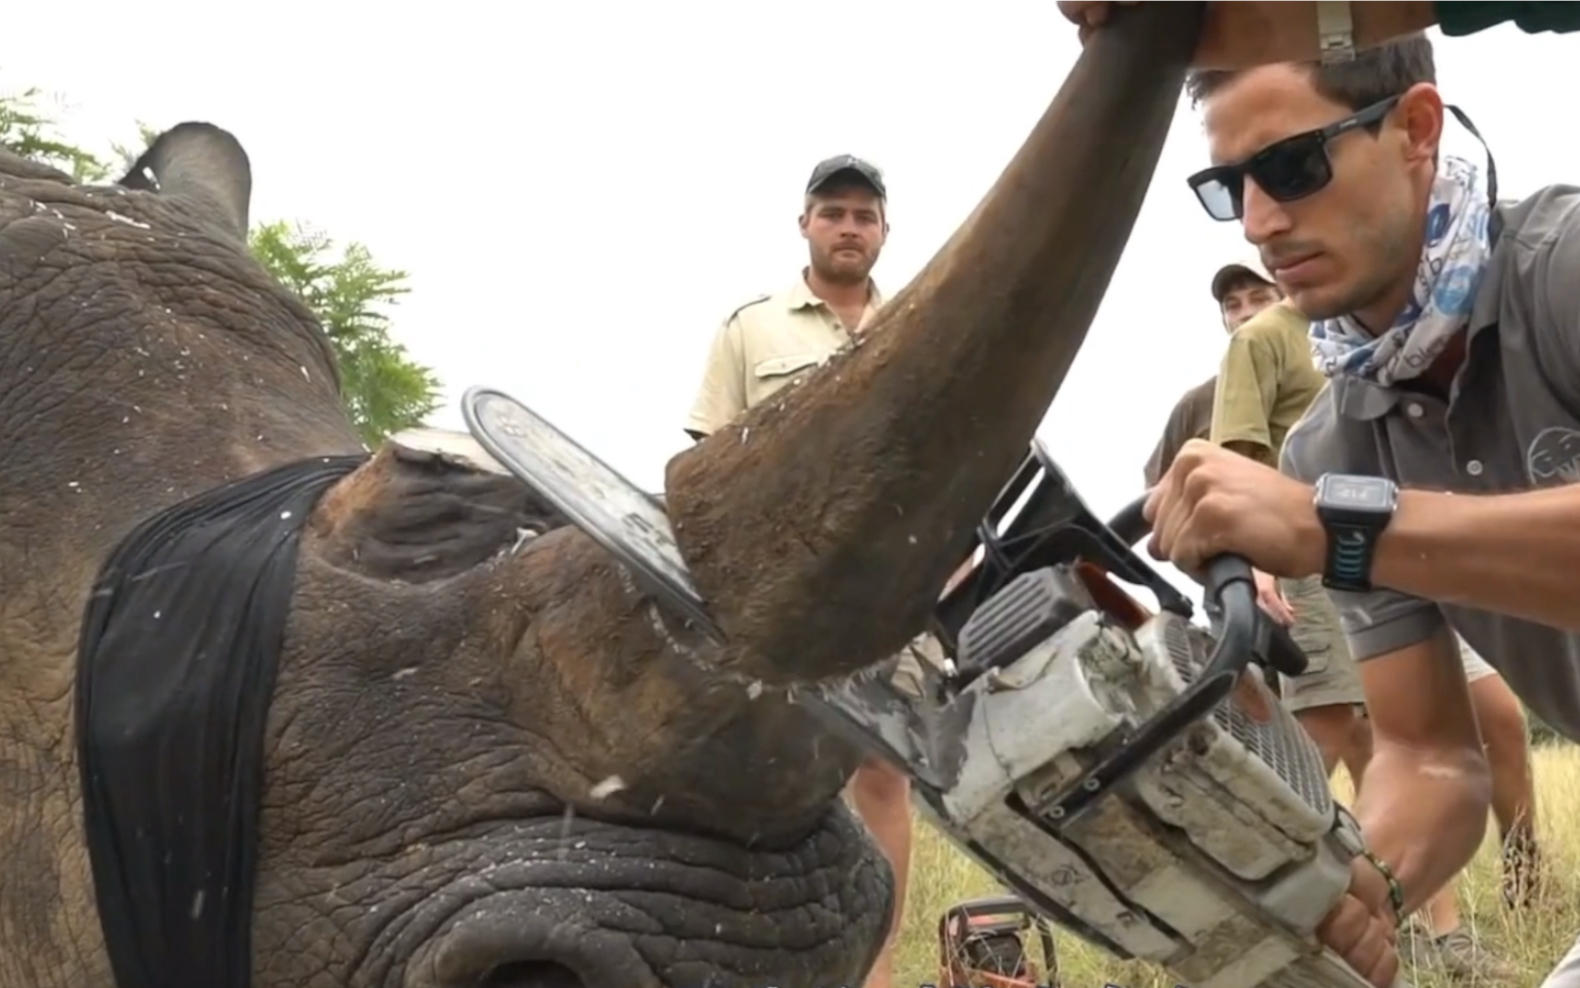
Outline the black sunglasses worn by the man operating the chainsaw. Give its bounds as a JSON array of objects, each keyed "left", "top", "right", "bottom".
[{"left": 1185, "top": 96, "right": 1400, "bottom": 221}]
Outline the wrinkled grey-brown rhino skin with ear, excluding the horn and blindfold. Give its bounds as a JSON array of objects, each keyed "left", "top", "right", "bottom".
[{"left": 0, "top": 125, "right": 890, "bottom": 988}]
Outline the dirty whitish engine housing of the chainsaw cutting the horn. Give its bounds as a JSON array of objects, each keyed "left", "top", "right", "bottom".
[{"left": 921, "top": 569, "right": 1357, "bottom": 988}]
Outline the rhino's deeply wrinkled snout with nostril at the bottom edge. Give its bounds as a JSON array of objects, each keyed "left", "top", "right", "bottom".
[{"left": 356, "top": 808, "right": 893, "bottom": 988}]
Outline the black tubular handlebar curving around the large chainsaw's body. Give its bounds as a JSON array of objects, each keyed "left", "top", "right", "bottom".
[{"left": 1049, "top": 496, "right": 1307, "bottom": 820}]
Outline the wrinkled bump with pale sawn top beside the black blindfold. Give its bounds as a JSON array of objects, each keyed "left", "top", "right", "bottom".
[{"left": 308, "top": 441, "right": 569, "bottom": 583}]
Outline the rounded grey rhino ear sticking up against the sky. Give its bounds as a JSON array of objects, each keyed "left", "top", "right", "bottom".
[{"left": 120, "top": 123, "right": 253, "bottom": 243}]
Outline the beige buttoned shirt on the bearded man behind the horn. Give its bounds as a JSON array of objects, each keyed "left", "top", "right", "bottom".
[{"left": 686, "top": 275, "right": 883, "bottom": 435}]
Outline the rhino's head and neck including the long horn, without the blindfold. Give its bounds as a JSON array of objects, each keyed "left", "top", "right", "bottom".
[{"left": 0, "top": 5, "right": 1199, "bottom": 988}]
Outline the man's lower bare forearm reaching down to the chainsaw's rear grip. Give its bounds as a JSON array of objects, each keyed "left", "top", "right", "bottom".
[{"left": 1354, "top": 740, "right": 1492, "bottom": 914}]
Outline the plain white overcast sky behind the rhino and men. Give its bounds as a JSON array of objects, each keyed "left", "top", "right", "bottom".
[{"left": 0, "top": 0, "right": 1580, "bottom": 600}]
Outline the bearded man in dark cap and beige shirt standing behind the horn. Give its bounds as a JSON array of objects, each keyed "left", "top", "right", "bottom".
[{"left": 686, "top": 155, "right": 916, "bottom": 988}]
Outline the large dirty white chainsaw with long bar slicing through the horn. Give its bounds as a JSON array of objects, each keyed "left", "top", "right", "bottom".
[{"left": 461, "top": 387, "right": 1409, "bottom": 988}]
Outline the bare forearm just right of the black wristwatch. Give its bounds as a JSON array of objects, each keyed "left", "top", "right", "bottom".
[{"left": 1371, "top": 485, "right": 1580, "bottom": 631}]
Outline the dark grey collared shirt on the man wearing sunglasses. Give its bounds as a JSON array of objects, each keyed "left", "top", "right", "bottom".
[{"left": 1281, "top": 185, "right": 1580, "bottom": 740}]
